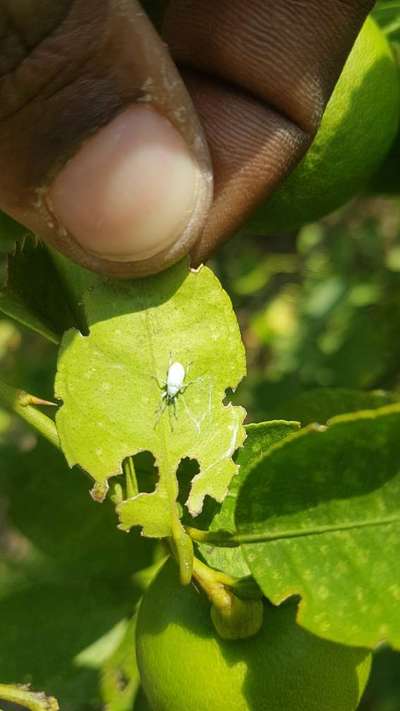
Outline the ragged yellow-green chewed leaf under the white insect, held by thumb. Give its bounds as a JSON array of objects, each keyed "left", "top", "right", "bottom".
[{"left": 56, "top": 263, "right": 245, "bottom": 536}]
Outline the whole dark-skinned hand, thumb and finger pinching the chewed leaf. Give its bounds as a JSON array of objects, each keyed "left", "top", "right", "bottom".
[{"left": 0, "top": 0, "right": 373, "bottom": 276}]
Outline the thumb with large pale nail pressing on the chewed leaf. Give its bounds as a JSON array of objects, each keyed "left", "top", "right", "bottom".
[{"left": 0, "top": 0, "right": 212, "bottom": 276}]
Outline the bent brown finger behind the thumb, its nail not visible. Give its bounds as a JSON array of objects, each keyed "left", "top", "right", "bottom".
[{"left": 163, "top": 0, "right": 373, "bottom": 263}]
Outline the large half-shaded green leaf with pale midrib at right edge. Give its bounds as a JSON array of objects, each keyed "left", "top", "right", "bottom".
[{"left": 236, "top": 405, "right": 400, "bottom": 647}]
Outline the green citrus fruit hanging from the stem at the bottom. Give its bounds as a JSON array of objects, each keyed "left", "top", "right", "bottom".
[{"left": 136, "top": 561, "right": 370, "bottom": 711}]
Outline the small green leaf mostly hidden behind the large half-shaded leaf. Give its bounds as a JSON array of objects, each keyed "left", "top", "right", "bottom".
[{"left": 200, "top": 420, "right": 299, "bottom": 578}]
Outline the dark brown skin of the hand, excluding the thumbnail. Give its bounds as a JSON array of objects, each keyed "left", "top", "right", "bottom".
[{"left": 0, "top": 0, "right": 374, "bottom": 277}]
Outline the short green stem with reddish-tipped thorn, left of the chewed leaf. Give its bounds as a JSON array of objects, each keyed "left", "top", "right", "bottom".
[{"left": 0, "top": 380, "right": 60, "bottom": 449}]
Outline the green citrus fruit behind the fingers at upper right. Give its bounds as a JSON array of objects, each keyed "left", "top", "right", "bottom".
[{"left": 248, "top": 18, "right": 400, "bottom": 233}]
